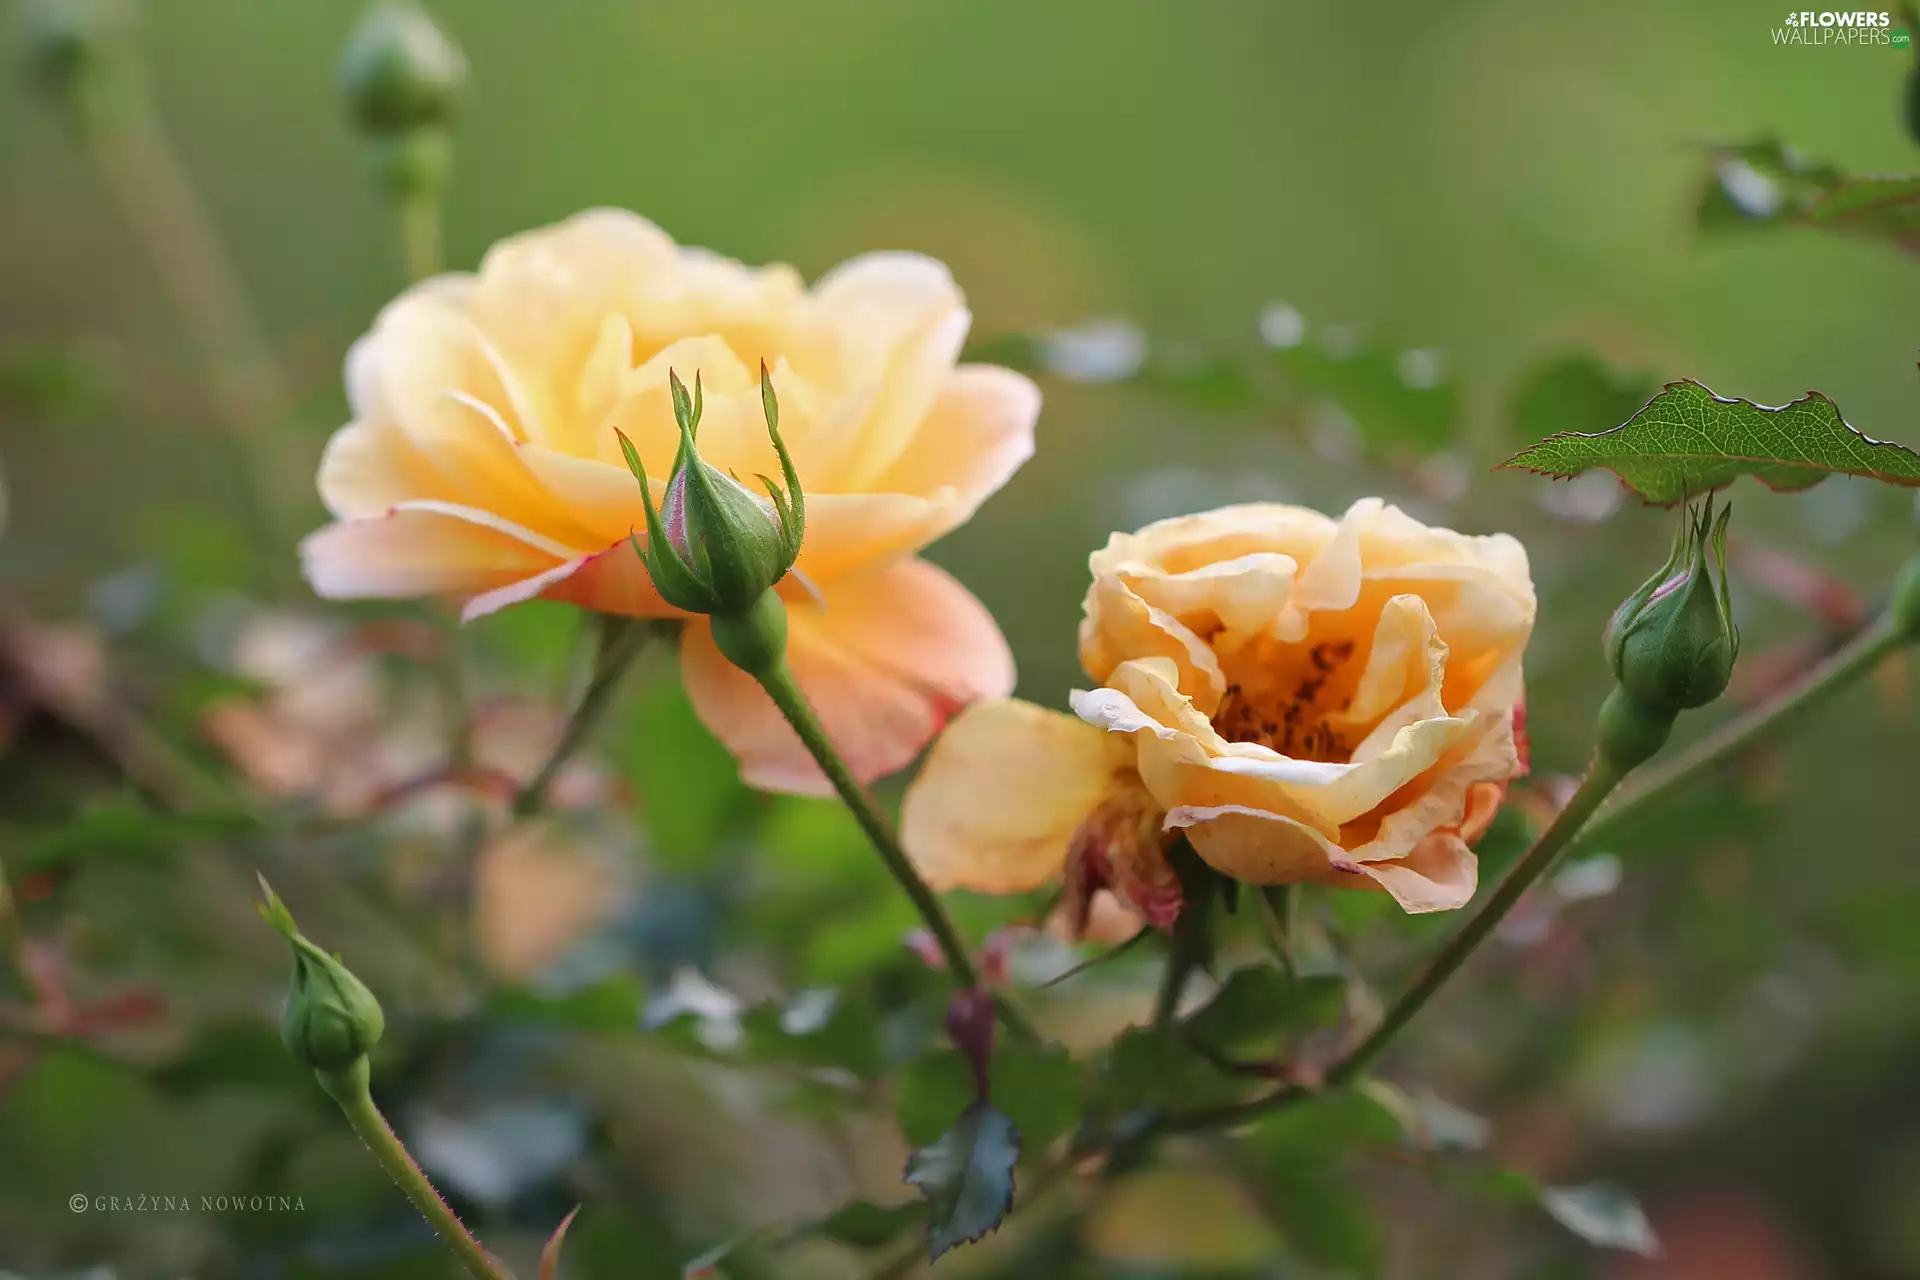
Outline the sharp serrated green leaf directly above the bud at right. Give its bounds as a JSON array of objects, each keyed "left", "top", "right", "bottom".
[{"left": 1501, "top": 382, "right": 1920, "bottom": 507}]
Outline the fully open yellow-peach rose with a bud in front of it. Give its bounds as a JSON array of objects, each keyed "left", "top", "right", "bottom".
[{"left": 301, "top": 209, "right": 1041, "bottom": 793}]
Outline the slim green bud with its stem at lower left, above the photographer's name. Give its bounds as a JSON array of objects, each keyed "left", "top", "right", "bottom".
[{"left": 259, "top": 879, "right": 513, "bottom": 1280}]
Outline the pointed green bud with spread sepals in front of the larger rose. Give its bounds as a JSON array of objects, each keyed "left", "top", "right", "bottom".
[{"left": 620, "top": 365, "right": 806, "bottom": 649}]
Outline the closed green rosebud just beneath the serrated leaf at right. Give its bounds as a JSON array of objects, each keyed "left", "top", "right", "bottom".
[{"left": 1607, "top": 497, "right": 1740, "bottom": 716}]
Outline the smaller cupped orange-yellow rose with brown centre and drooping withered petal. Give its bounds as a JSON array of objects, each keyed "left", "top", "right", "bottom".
[{"left": 902, "top": 499, "right": 1534, "bottom": 925}]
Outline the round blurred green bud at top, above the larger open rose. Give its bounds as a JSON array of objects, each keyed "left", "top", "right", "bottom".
[{"left": 340, "top": 0, "right": 467, "bottom": 134}]
